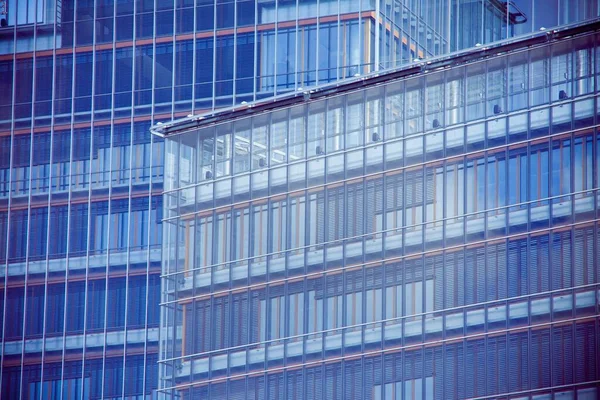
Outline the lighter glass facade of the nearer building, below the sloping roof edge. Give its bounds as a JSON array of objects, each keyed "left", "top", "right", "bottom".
[{"left": 158, "top": 23, "right": 600, "bottom": 400}]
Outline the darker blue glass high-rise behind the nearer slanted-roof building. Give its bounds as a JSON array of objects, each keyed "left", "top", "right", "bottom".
[{"left": 0, "top": 0, "right": 598, "bottom": 399}]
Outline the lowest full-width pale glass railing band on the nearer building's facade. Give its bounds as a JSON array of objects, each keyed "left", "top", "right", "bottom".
[{"left": 162, "top": 284, "right": 600, "bottom": 379}]
